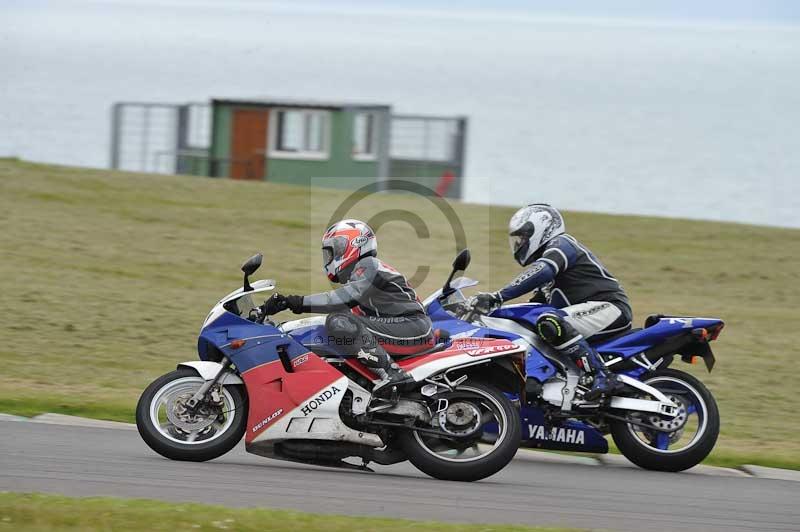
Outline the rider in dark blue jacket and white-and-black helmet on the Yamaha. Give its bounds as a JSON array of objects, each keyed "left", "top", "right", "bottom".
[{"left": 471, "top": 204, "right": 632, "bottom": 400}]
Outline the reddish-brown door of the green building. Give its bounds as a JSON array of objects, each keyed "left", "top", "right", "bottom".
[{"left": 229, "top": 109, "right": 269, "bottom": 180}]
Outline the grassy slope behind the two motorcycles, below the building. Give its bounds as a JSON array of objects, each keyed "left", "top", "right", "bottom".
[{"left": 0, "top": 159, "right": 800, "bottom": 466}]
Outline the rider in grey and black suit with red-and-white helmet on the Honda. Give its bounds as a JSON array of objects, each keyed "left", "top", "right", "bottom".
[{"left": 265, "top": 220, "right": 433, "bottom": 397}]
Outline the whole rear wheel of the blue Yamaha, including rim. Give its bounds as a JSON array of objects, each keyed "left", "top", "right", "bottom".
[{"left": 611, "top": 369, "right": 719, "bottom": 472}]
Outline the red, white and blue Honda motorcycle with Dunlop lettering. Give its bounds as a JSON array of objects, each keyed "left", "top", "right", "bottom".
[{"left": 136, "top": 254, "right": 525, "bottom": 481}]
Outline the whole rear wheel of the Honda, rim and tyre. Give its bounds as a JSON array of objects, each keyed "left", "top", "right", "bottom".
[{"left": 399, "top": 382, "right": 522, "bottom": 482}]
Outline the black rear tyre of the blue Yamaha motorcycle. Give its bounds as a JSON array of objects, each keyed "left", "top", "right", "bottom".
[{"left": 611, "top": 369, "right": 719, "bottom": 472}]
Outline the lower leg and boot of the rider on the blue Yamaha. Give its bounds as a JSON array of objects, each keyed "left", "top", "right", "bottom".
[{"left": 536, "top": 313, "right": 623, "bottom": 401}]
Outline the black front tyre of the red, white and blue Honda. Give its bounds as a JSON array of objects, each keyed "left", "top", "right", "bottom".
[{"left": 136, "top": 368, "right": 247, "bottom": 462}]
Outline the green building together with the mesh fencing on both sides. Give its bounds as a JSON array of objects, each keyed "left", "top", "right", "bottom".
[{"left": 111, "top": 99, "right": 466, "bottom": 198}]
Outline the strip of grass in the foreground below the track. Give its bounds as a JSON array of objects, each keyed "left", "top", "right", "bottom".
[{"left": 0, "top": 493, "right": 580, "bottom": 532}]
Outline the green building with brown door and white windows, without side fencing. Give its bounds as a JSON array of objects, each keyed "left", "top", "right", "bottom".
[{"left": 205, "top": 100, "right": 391, "bottom": 191}]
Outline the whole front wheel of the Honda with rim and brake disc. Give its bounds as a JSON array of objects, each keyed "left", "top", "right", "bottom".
[{"left": 136, "top": 368, "right": 247, "bottom": 462}]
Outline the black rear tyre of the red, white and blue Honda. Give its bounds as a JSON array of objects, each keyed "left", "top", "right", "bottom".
[{"left": 399, "top": 382, "right": 522, "bottom": 482}]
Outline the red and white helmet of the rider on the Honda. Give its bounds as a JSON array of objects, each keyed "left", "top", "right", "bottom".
[{"left": 322, "top": 220, "right": 378, "bottom": 283}]
